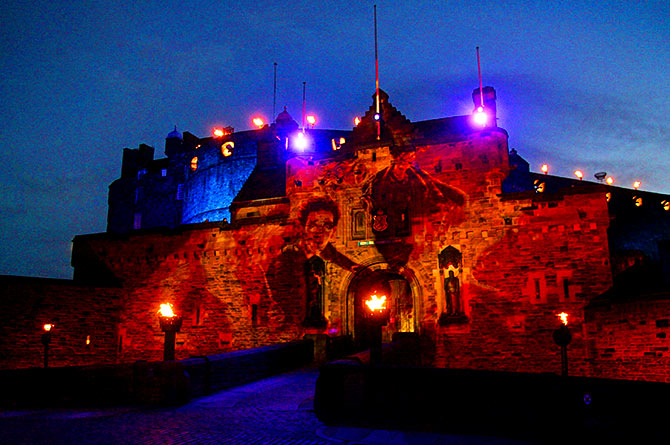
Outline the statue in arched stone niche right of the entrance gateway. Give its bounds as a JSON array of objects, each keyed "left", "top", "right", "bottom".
[{"left": 438, "top": 246, "right": 466, "bottom": 325}]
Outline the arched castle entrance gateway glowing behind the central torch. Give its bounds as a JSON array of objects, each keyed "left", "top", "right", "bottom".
[{"left": 347, "top": 263, "right": 420, "bottom": 349}]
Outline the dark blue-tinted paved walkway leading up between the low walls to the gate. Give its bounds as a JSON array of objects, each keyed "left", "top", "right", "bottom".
[{"left": 0, "top": 368, "right": 536, "bottom": 445}]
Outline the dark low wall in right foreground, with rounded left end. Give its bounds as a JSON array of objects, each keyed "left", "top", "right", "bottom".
[{"left": 314, "top": 359, "right": 670, "bottom": 443}]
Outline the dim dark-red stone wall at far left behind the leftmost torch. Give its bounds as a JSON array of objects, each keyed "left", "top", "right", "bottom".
[{"left": 0, "top": 276, "right": 121, "bottom": 369}]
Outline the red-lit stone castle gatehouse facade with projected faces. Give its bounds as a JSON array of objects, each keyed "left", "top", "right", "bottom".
[{"left": 3, "top": 88, "right": 670, "bottom": 381}]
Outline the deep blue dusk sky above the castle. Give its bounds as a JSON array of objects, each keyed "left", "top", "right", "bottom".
[{"left": 0, "top": 0, "right": 670, "bottom": 278}]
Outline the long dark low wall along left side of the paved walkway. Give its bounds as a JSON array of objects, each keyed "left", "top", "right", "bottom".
[{"left": 0, "top": 340, "right": 313, "bottom": 408}]
